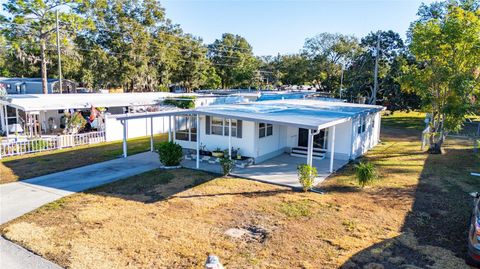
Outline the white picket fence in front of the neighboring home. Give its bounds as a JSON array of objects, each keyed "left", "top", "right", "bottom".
[{"left": 0, "top": 131, "right": 105, "bottom": 159}]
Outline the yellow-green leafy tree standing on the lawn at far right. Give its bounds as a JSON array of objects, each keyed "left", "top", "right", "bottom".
[{"left": 402, "top": 1, "right": 480, "bottom": 153}]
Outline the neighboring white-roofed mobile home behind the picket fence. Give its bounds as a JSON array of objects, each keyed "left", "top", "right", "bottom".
[{"left": 0, "top": 92, "right": 255, "bottom": 141}]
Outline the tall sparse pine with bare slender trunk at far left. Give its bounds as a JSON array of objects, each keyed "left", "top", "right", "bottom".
[{"left": 0, "top": 0, "right": 87, "bottom": 94}]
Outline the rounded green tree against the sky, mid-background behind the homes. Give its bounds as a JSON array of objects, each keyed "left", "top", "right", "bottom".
[{"left": 208, "top": 33, "right": 259, "bottom": 88}]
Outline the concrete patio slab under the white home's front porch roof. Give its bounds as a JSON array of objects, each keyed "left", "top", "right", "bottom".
[{"left": 182, "top": 154, "right": 348, "bottom": 188}]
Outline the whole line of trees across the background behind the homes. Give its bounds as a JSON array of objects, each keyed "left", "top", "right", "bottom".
[{"left": 0, "top": 0, "right": 474, "bottom": 127}]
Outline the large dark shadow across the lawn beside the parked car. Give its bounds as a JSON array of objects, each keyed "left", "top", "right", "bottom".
[{"left": 341, "top": 149, "right": 480, "bottom": 268}]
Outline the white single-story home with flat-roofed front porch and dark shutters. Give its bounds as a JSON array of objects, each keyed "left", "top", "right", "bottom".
[{"left": 119, "top": 99, "right": 384, "bottom": 185}]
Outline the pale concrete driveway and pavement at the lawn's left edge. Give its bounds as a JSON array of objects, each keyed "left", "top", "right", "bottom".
[{"left": 0, "top": 152, "right": 160, "bottom": 269}]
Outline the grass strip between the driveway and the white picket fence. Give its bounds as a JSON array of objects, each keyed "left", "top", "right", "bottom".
[{"left": 0, "top": 135, "right": 166, "bottom": 184}]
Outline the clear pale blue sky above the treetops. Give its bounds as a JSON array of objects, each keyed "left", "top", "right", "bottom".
[{"left": 161, "top": 0, "right": 431, "bottom": 55}]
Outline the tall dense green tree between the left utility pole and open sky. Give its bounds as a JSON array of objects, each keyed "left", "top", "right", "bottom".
[{"left": 78, "top": 0, "right": 169, "bottom": 91}]
